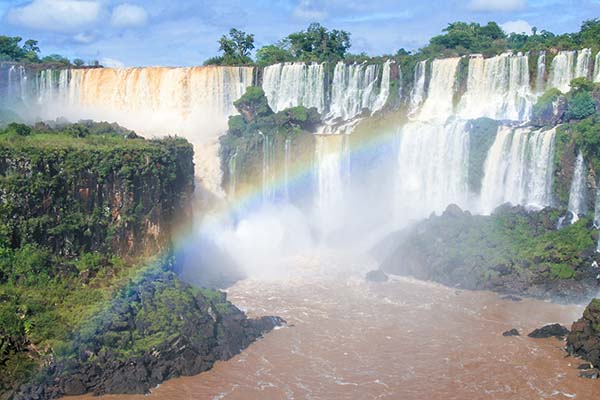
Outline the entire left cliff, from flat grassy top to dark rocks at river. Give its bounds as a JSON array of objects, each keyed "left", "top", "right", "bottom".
[{"left": 0, "top": 122, "right": 282, "bottom": 400}]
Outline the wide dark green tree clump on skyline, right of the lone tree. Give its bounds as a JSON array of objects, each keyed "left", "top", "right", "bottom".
[{"left": 284, "top": 23, "right": 351, "bottom": 62}]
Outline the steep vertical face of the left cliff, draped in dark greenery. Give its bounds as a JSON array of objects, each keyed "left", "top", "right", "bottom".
[{"left": 0, "top": 131, "right": 194, "bottom": 257}]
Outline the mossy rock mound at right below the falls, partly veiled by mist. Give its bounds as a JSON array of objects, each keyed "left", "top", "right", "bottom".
[{"left": 381, "top": 205, "right": 600, "bottom": 301}]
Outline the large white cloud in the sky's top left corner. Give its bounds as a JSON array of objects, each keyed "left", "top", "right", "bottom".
[{"left": 7, "top": 0, "right": 101, "bottom": 32}]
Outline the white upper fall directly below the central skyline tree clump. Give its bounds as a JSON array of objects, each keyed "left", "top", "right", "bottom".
[{"left": 262, "top": 63, "right": 326, "bottom": 113}]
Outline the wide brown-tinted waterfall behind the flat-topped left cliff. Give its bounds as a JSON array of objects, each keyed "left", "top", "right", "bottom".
[{"left": 11, "top": 67, "right": 254, "bottom": 196}]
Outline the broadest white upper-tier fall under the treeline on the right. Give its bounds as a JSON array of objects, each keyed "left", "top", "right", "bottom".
[{"left": 459, "top": 53, "right": 534, "bottom": 121}]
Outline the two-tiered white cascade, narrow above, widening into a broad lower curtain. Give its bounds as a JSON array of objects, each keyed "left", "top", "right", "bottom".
[{"left": 395, "top": 58, "right": 469, "bottom": 219}]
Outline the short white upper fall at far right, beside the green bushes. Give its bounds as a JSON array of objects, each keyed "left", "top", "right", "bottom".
[{"left": 549, "top": 49, "right": 591, "bottom": 93}]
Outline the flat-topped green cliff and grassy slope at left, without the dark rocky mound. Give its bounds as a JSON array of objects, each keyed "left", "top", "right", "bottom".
[{"left": 0, "top": 122, "right": 193, "bottom": 393}]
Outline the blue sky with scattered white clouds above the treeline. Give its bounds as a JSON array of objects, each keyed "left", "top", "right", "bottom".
[{"left": 0, "top": 0, "right": 600, "bottom": 66}]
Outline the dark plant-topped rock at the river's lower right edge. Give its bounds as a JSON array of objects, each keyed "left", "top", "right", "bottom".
[{"left": 567, "top": 299, "right": 600, "bottom": 366}]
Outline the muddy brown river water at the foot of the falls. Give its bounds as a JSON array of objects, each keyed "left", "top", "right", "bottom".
[{"left": 69, "top": 255, "right": 600, "bottom": 400}]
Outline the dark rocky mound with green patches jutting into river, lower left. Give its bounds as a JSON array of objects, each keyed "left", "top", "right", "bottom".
[{"left": 14, "top": 269, "right": 285, "bottom": 400}]
